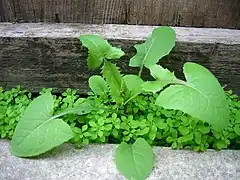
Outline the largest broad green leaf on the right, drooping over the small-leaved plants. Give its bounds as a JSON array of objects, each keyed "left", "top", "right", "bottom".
[{"left": 156, "top": 62, "right": 229, "bottom": 129}]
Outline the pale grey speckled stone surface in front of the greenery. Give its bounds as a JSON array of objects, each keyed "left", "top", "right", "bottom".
[{"left": 0, "top": 140, "right": 240, "bottom": 180}]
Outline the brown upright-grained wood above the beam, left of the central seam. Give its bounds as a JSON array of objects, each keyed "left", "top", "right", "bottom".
[{"left": 2, "top": 0, "right": 126, "bottom": 24}]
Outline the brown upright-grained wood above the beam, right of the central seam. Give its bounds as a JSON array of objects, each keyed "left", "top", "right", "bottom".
[{"left": 128, "top": 0, "right": 240, "bottom": 28}]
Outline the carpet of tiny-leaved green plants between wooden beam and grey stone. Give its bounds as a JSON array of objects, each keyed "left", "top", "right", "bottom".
[{"left": 0, "top": 87, "right": 240, "bottom": 151}]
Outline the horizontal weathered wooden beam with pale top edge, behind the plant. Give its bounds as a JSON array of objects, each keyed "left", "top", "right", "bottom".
[{"left": 0, "top": 23, "right": 240, "bottom": 93}]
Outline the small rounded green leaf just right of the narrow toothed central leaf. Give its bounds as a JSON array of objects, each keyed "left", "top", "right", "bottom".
[{"left": 123, "top": 75, "right": 143, "bottom": 104}]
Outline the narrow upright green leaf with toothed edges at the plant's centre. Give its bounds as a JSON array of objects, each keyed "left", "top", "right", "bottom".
[{"left": 102, "top": 61, "right": 123, "bottom": 104}]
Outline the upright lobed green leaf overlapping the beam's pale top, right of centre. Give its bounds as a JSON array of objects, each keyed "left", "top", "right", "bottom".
[{"left": 129, "top": 27, "right": 176, "bottom": 67}]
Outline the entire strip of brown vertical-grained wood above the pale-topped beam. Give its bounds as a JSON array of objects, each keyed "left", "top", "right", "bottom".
[{"left": 0, "top": 0, "right": 240, "bottom": 29}]
